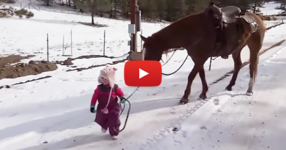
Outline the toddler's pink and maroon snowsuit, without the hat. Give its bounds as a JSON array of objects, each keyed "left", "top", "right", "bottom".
[{"left": 91, "top": 84, "right": 124, "bottom": 136}]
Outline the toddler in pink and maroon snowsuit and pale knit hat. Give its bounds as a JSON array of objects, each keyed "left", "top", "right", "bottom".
[{"left": 90, "top": 66, "right": 126, "bottom": 139}]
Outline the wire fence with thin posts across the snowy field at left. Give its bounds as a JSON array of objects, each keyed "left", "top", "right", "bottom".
[{"left": 0, "top": 30, "right": 135, "bottom": 61}]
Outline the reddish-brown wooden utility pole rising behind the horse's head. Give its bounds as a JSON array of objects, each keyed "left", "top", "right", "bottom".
[{"left": 129, "top": 0, "right": 138, "bottom": 52}]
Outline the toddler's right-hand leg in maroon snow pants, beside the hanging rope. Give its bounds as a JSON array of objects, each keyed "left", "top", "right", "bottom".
[{"left": 108, "top": 111, "right": 121, "bottom": 136}]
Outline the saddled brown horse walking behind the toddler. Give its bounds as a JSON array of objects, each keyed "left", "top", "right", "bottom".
[{"left": 141, "top": 3, "right": 266, "bottom": 103}]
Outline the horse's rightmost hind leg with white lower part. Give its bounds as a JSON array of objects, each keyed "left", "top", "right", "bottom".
[{"left": 246, "top": 36, "right": 262, "bottom": 96}]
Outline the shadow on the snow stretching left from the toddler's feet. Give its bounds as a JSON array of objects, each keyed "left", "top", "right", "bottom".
[{"left": 20, "top": 133, "right": 111, "bottom": 150}]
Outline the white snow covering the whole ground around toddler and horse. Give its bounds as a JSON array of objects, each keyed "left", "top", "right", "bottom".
[{"left": 0, "top": 1, "right": 286, "bottom": 150}]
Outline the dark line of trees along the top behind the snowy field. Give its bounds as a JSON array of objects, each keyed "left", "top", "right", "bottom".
[{"left": 0, "top": 0, "right": 286, "bottom": 24}]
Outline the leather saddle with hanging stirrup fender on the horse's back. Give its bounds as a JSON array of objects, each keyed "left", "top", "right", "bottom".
[{"left": 215, "top": 6, "right": 258, "bottom": 59}]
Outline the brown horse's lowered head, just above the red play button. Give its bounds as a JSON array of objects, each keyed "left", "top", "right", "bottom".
[{"left": 140, "top": 35, "right": 163, "bottom": 61}]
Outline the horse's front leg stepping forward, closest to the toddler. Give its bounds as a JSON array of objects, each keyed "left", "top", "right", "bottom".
[{"left": 180, "top": 64, "right": 203, "bottom": 103}]
